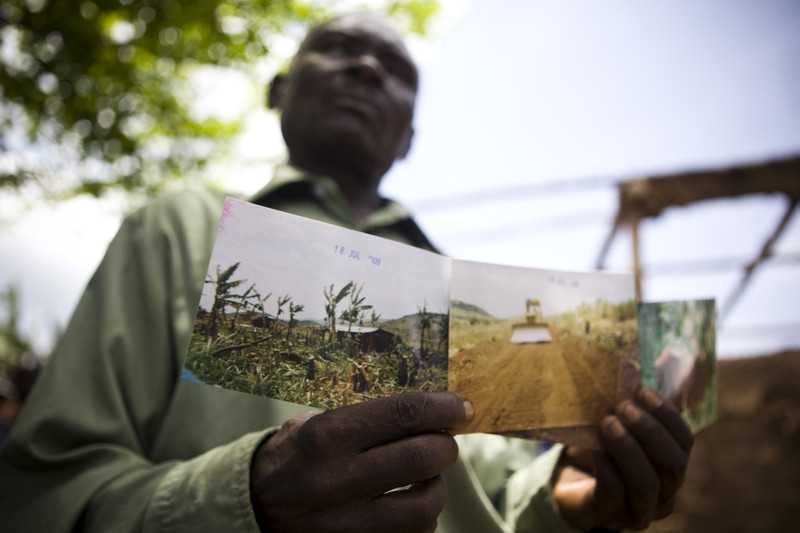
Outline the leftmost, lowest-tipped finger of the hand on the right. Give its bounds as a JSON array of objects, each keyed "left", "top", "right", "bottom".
[{"left": 601, "top": 416, "right": 660, "bottom": 528}]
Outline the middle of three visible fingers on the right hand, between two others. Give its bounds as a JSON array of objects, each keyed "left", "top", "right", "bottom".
[{"left": 618, "top": 401, "right": 689, "bottom": 508}]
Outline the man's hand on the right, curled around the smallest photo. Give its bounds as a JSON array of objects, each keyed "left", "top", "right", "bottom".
[{"left": 553, "top": 389, "right": 694, "bottom": 530}]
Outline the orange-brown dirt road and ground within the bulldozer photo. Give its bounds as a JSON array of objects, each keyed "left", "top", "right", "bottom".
[{"left": 448, "top": 312, "right": 636, "bottom": 440}]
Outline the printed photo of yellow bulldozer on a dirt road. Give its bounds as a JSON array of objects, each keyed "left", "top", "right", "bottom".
[{"left": 449, "top": 261, "right": 637, "bottom": 443}]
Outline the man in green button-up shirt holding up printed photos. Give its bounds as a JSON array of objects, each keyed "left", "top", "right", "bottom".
[{"left": 0, "top": 15, "right": 691, "bottom": 533}]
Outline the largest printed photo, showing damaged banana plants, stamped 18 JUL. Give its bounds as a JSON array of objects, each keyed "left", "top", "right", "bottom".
[{"left": 184, "top": 198, "right": 450, "bottom": 409}]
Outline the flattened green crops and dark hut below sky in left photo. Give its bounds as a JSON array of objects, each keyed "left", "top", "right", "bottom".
[{"left": 186, "top": 264, "right": 448, "bottom": 409}]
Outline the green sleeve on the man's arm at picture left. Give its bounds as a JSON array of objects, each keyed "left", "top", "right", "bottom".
[{"left": 0, "top": 192, "right": 265, "bottom": 532}]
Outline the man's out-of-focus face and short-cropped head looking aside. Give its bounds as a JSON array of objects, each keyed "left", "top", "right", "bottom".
[{"left": 276, "top": 15, "right": 417, "bottom": 179}]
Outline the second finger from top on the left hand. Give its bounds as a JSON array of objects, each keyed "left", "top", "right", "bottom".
[{"left": 332, "top": 432, "right": 458, "bottom": 498}]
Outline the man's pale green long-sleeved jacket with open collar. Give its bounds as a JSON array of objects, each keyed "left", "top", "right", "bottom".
[{"left": 0, "top": 167, "right": 571, "bottom": 533}]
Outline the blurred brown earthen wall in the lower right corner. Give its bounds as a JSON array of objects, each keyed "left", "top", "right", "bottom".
[{"left": 647, "top": 352, "right": 800, "bottom": 533}]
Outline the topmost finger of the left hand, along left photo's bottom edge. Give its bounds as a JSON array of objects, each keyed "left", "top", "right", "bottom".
[{"left": 300, "top": 392, "right": 474, "bottom": 455}]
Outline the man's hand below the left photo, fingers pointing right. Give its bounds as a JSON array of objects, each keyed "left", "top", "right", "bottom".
[{"left": 250, "top": 393, "right": 474, "bottom": 533}]
